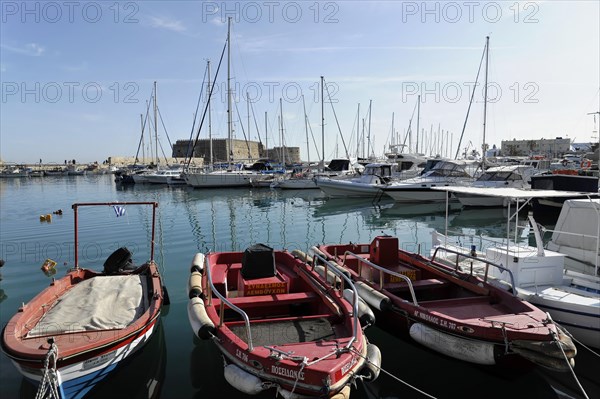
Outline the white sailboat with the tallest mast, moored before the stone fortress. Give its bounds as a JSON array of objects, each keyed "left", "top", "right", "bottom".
[{"left": 183, "top": 17, "right": 265, "bottom": 188}]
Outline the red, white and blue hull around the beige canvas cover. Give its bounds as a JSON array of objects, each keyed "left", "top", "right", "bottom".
[{"left": 2, "top": 262, "right": 163, "bottom": 399}]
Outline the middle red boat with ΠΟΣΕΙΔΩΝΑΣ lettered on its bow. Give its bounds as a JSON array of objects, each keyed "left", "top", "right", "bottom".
[{"left": 188, "top": 244, "right": 381, "bottom": 398}]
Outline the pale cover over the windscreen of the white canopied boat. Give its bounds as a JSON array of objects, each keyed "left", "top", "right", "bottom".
[{"left": 548, "top": 199, "right": 600, "bottom": 264}]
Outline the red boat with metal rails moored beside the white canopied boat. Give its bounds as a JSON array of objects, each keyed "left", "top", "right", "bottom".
[{"left": 313, "top": 236, "right": 576, "bottom": 371}]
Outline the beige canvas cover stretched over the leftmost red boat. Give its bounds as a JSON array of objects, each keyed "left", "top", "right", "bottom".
[{"left": 28, "top": 275, "right": 147, "bottom": 337}]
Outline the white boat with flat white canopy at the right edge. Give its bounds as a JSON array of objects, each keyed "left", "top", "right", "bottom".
[{"left": 432, "top": 186, "right": 600, "bottom": 348}]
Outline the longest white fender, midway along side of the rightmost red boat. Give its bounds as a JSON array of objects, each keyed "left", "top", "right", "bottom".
[{"left": 409, "top": 323, "right": 496, "bottom": 365}]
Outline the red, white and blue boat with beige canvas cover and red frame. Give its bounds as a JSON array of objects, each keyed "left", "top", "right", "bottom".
[{"left": 1, "top": 202, "right": 168, "bottom": 399}]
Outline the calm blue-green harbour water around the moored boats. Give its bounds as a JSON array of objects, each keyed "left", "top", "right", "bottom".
[{"left": 0, "top": 175, "right": 600, "bottom": 399}]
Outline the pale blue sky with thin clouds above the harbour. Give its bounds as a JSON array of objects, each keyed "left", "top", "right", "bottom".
[{"left": 0, "top": 0, "right": 600, "bottom": 163}]
